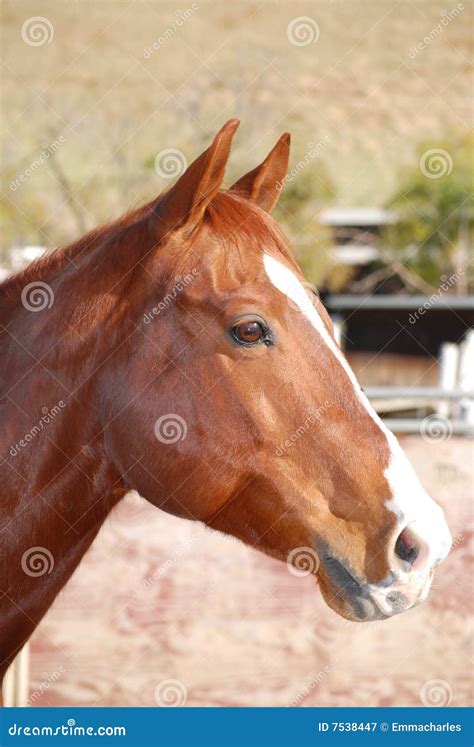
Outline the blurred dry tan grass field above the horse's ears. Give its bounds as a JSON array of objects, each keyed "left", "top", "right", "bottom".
[{"left": 2, "top": 0, "right": 472, "bottom": 250}]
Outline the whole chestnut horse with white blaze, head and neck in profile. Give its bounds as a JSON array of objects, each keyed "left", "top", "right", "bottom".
[{"left": 0, "top": 120, "right": 451, "bottom": 696}]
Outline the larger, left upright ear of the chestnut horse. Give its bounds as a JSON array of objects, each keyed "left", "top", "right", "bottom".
[{"left": 153, "top": 119, "right": 240, "bottom": 238}]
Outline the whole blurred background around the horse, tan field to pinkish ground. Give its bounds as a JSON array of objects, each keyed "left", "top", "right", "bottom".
[{"left": 0, "top": 0, "right": 474, "bottom": 706}]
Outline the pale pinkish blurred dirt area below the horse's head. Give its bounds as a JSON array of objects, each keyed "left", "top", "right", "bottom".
[{"left": 30, "top": 436, "right": 473, "bottom": 706}]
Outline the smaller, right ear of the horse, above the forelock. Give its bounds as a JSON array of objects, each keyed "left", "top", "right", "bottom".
[{"left": 231, "top": 132, "right": 291, "bottom": 213}]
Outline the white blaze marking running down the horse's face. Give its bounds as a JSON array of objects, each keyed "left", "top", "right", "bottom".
[{"left": 263, "top": 254, "right": 451, "bottom": 565}]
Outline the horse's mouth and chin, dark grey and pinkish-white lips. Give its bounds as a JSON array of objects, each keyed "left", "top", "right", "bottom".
[{"left": 321, "top": 556, "right": 413, "bottom": 622}]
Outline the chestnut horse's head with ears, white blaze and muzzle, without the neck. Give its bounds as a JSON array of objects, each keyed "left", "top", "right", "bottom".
[{"left": 102, "top": 120, "right": 451, "bottom": 620}]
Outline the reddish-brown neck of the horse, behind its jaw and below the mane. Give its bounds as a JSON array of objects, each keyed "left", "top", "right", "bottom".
[{"left": 0, "top": 221, "right": 153, "bottom": 677}]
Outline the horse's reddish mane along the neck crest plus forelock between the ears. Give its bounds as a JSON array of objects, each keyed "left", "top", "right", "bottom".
[{"left": 0, "top": 190, "right": 292, "bottom": 316}]
